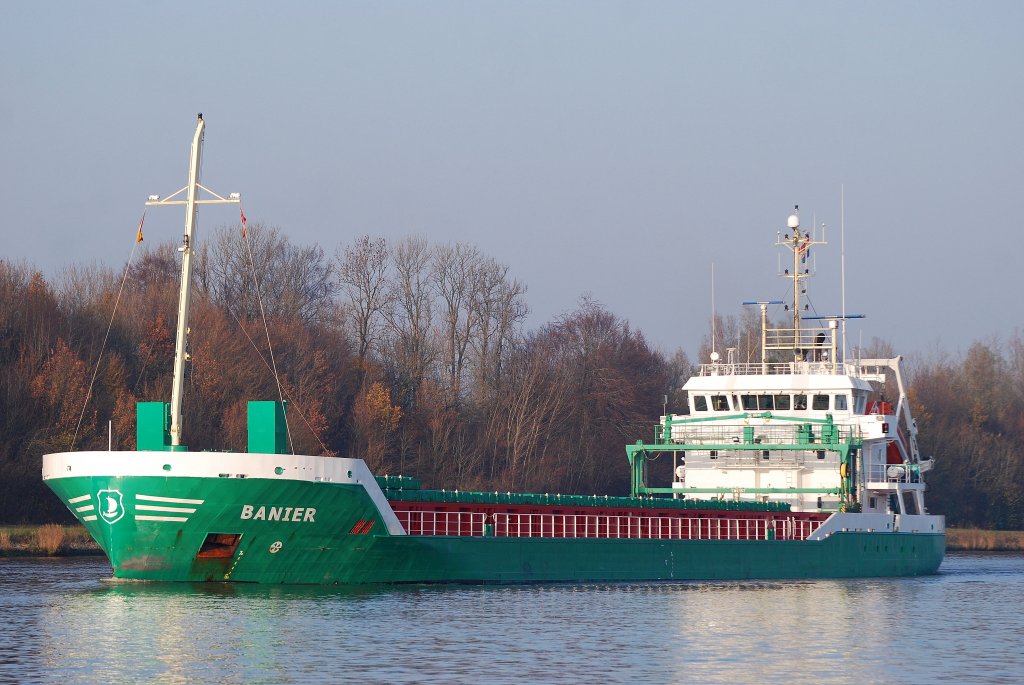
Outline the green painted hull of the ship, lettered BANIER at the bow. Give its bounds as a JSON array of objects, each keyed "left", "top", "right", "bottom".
[{"left": 47, "top": 472, "right": 945, "bottom": 584}]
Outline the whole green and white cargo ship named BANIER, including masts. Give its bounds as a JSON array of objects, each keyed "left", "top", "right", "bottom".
[{"left": 42, "top": 115, "right": 945, "bottom": 584}]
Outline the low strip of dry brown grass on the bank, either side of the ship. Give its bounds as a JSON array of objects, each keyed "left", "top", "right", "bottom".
[{"left": 0, "top": 523, "right": 1024, "bottom": 557}]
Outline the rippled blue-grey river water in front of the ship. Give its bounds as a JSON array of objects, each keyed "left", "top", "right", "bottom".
[{"left": 0, "top": 554, "right": 1024, "bottom": 685}]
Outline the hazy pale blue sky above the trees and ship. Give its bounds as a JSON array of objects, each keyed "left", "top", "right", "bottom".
[{"left": 0, "top": 1, "right": 1024, "bottom": 355}]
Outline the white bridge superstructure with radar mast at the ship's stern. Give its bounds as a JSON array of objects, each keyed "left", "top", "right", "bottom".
[{"left": 659, "top": 205, "right": 932, "bottom": 516}]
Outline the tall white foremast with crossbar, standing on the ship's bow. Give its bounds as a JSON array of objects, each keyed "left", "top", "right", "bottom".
[{"left": 145, "top": 113, "right": 242, "bottom": 448}]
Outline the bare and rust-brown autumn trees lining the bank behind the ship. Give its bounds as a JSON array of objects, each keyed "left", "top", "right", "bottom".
[{"left": 0, "top": 224, "right": 1024, "bottom": 529}]
